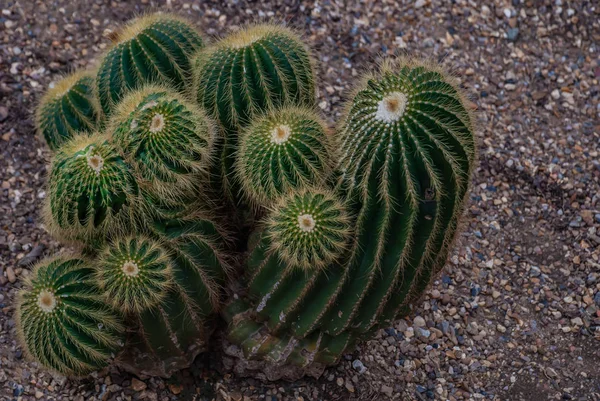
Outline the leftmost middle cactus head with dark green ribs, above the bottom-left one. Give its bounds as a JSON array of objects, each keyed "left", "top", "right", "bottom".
[{"left": 44, "top": 134, "right": 139, "bottom": 244}]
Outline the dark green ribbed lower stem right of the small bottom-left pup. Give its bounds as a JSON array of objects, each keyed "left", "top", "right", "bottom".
[{"left": 126, "top": 216, "right": 227, "bottom": 360}]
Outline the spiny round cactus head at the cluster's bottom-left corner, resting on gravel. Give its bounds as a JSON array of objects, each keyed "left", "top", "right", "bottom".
[{"left": 16, "top": 256, "right": 124, "bottom": 377}]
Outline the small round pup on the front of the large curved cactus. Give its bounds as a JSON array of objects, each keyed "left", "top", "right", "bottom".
[{"left": 266, "top": 190, "right": 351, "bottom": 270}]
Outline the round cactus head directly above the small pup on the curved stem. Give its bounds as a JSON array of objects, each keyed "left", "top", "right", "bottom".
[{"left": 236, "top": 107, "right": 332, "bottom": 205}]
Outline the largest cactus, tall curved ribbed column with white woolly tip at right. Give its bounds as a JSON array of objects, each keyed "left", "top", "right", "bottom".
[{"left": 226, "top": 59, "right": 475, "bottom": 376}]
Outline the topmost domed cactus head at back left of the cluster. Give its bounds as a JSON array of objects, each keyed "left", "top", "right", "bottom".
[{"left": 96, "top": 14, "right": 203, "bottom": 115}]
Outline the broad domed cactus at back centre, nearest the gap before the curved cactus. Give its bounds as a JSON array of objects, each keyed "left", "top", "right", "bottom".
[{"left": 193, "top": 25, "right": 315, "bottom": 195}]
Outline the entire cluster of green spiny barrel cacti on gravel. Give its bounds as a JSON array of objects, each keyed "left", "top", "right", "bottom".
[{"left": 17, "top": 14, "right": 475, "bottom": 379}]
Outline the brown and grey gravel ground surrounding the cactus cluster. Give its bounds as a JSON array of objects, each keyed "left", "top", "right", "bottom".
[{"left": 0, "top": 0, "right": 600, "bottom": 401}]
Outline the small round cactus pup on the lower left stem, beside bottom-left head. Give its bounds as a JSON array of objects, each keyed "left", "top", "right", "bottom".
[{"left": 96, "top": 237, "right": 173, "bottom": 314}]
